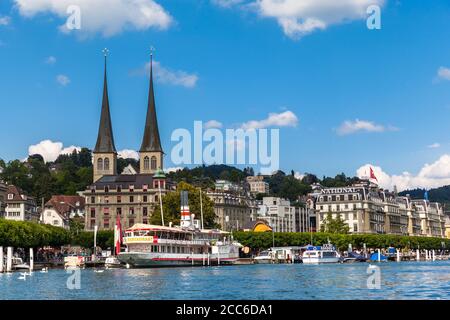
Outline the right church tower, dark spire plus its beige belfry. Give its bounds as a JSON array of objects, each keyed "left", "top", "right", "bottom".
[{"left": 139, "top": 53, "right": 164, "bottom": 174}]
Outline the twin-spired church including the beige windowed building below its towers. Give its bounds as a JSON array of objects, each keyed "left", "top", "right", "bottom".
[{"left": 84, "top": 56, "right": 169, "bottom": 230}]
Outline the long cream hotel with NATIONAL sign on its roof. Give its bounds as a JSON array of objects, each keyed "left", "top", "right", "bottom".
[{"left": 310, "top": 180, "right": 445, "bottom": 237}]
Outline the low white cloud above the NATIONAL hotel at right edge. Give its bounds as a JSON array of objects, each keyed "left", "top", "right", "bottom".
[{"left": 356, "top": 154, "right": 450, "bottom": 191}]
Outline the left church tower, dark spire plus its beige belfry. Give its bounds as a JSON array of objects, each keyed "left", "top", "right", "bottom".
[{"left": 93, "top": 49, "right": 117, "bottom": 182}]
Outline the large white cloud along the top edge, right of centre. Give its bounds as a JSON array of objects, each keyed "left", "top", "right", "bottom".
[{"left": 212, "top": 0, "right": 385, "bottom": 39}]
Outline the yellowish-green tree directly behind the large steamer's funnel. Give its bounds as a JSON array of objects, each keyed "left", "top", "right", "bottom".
[{"left": 150, "top": 182, "right": 218, "bottom": 228}]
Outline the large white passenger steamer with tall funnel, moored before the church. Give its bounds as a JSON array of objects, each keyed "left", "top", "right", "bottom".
[{"left": 117, "top": 191, "right": 242, "bottom": 268}]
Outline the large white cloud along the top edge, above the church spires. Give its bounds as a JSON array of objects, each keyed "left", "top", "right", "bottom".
[{"left": 14, "top": 0, "right": 173, "bottom": 37}]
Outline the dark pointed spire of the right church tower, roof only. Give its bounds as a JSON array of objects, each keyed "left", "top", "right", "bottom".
[{"left": 139, "top": 48, "right": 163, "bottom": 152}]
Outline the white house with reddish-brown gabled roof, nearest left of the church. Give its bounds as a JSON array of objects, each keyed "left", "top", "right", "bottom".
[{"left": 41, "top": 196, "right": 85, "bottom": 229}]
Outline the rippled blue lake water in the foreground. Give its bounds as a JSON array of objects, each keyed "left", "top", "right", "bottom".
[{"left": 0, "top": 261, "right": 450, "bottom": 300}]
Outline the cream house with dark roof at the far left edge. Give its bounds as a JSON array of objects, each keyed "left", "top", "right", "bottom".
[{"left": 4, "top": 185, "right": 39, "bottom": 221}]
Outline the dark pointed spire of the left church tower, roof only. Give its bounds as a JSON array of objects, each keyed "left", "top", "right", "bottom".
[{"left": 94, "top": 48, "right": 117, "bottom": 153}]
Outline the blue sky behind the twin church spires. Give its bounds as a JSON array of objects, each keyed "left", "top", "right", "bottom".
[{"left": 0, "top": 0, "right": 450, "bottom": 187}]
